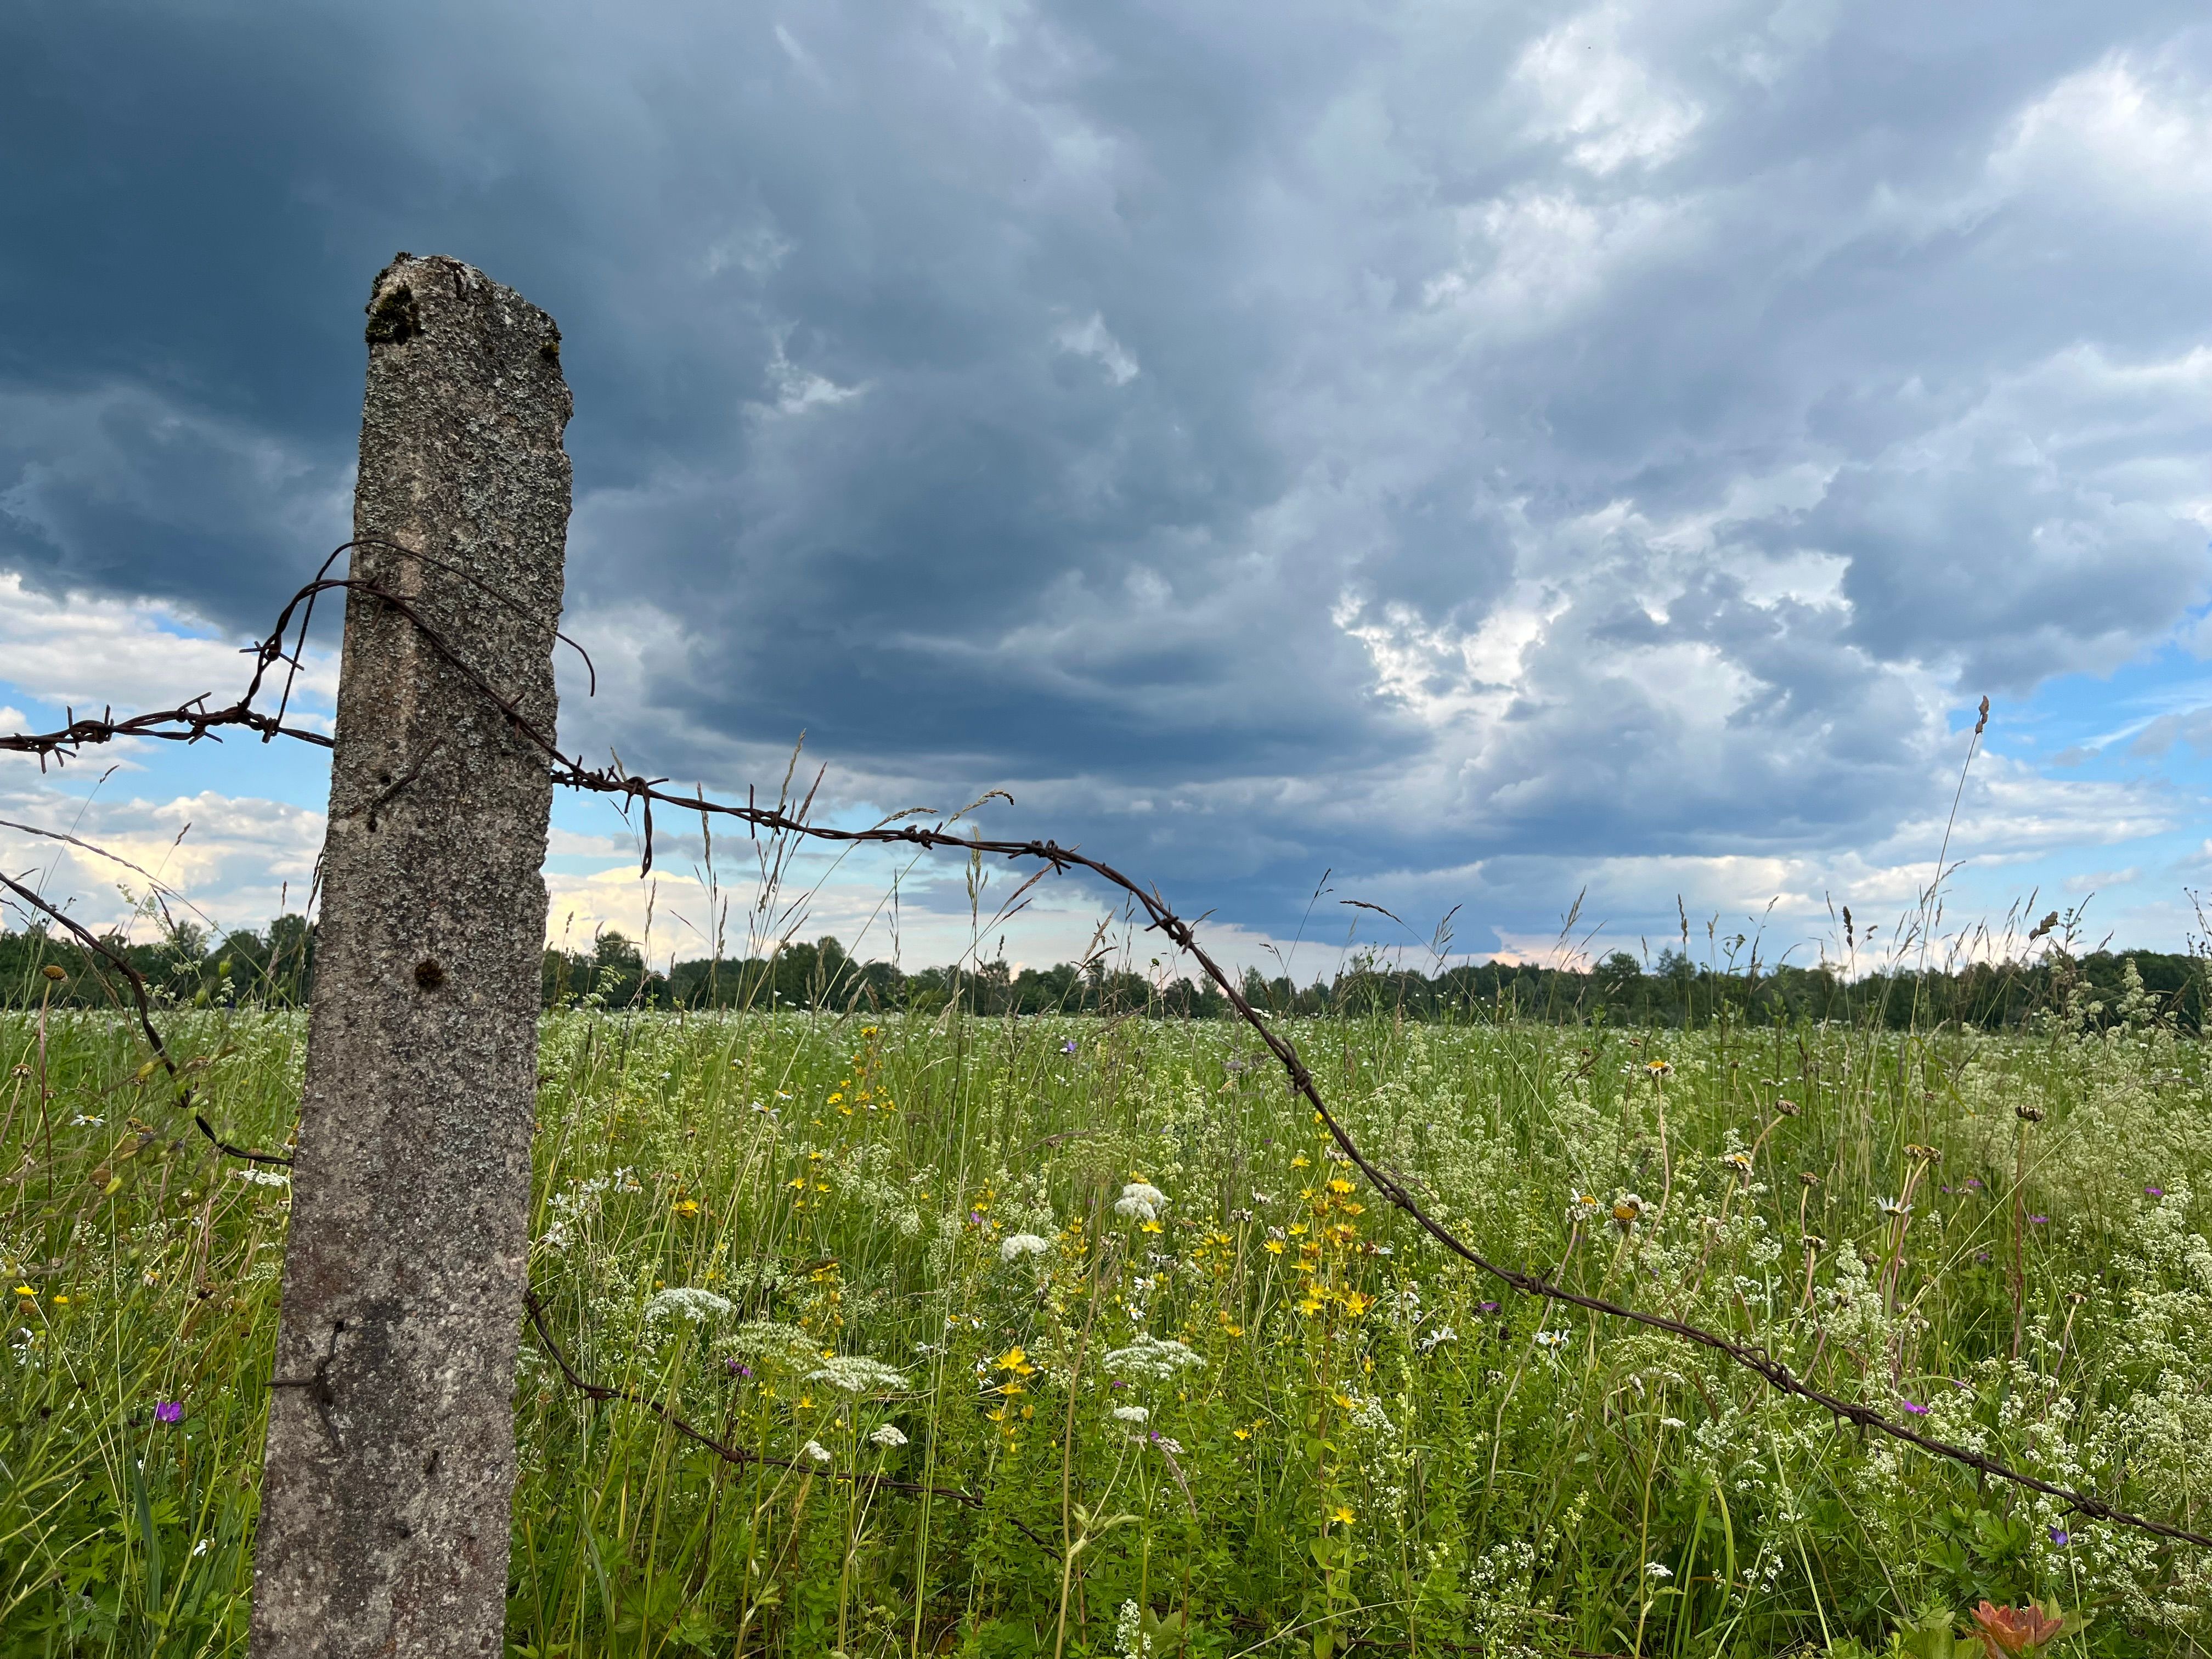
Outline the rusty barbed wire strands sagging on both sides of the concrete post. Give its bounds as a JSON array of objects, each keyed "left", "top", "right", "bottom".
[{"left": 0, "top": 553, "right": 2212, "bottom": 1548}]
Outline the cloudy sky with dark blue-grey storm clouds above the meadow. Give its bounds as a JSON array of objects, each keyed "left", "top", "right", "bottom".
[{"left": 0, "top": 0, "right": 2212, "bottom": 964}]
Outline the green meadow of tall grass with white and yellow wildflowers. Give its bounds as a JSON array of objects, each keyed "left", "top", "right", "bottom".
[{"left": 0, "top": 1000, "right": 2212, "bottom": 1659}]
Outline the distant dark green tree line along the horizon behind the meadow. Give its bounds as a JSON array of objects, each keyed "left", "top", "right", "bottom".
[{"left": 0, "top": 916, "right": 2208, "bottom": 1031}]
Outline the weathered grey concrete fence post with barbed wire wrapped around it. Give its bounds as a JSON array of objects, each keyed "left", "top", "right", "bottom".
[{"left": 252, "top": 255, "right": 571, "bottom": 1659}]
